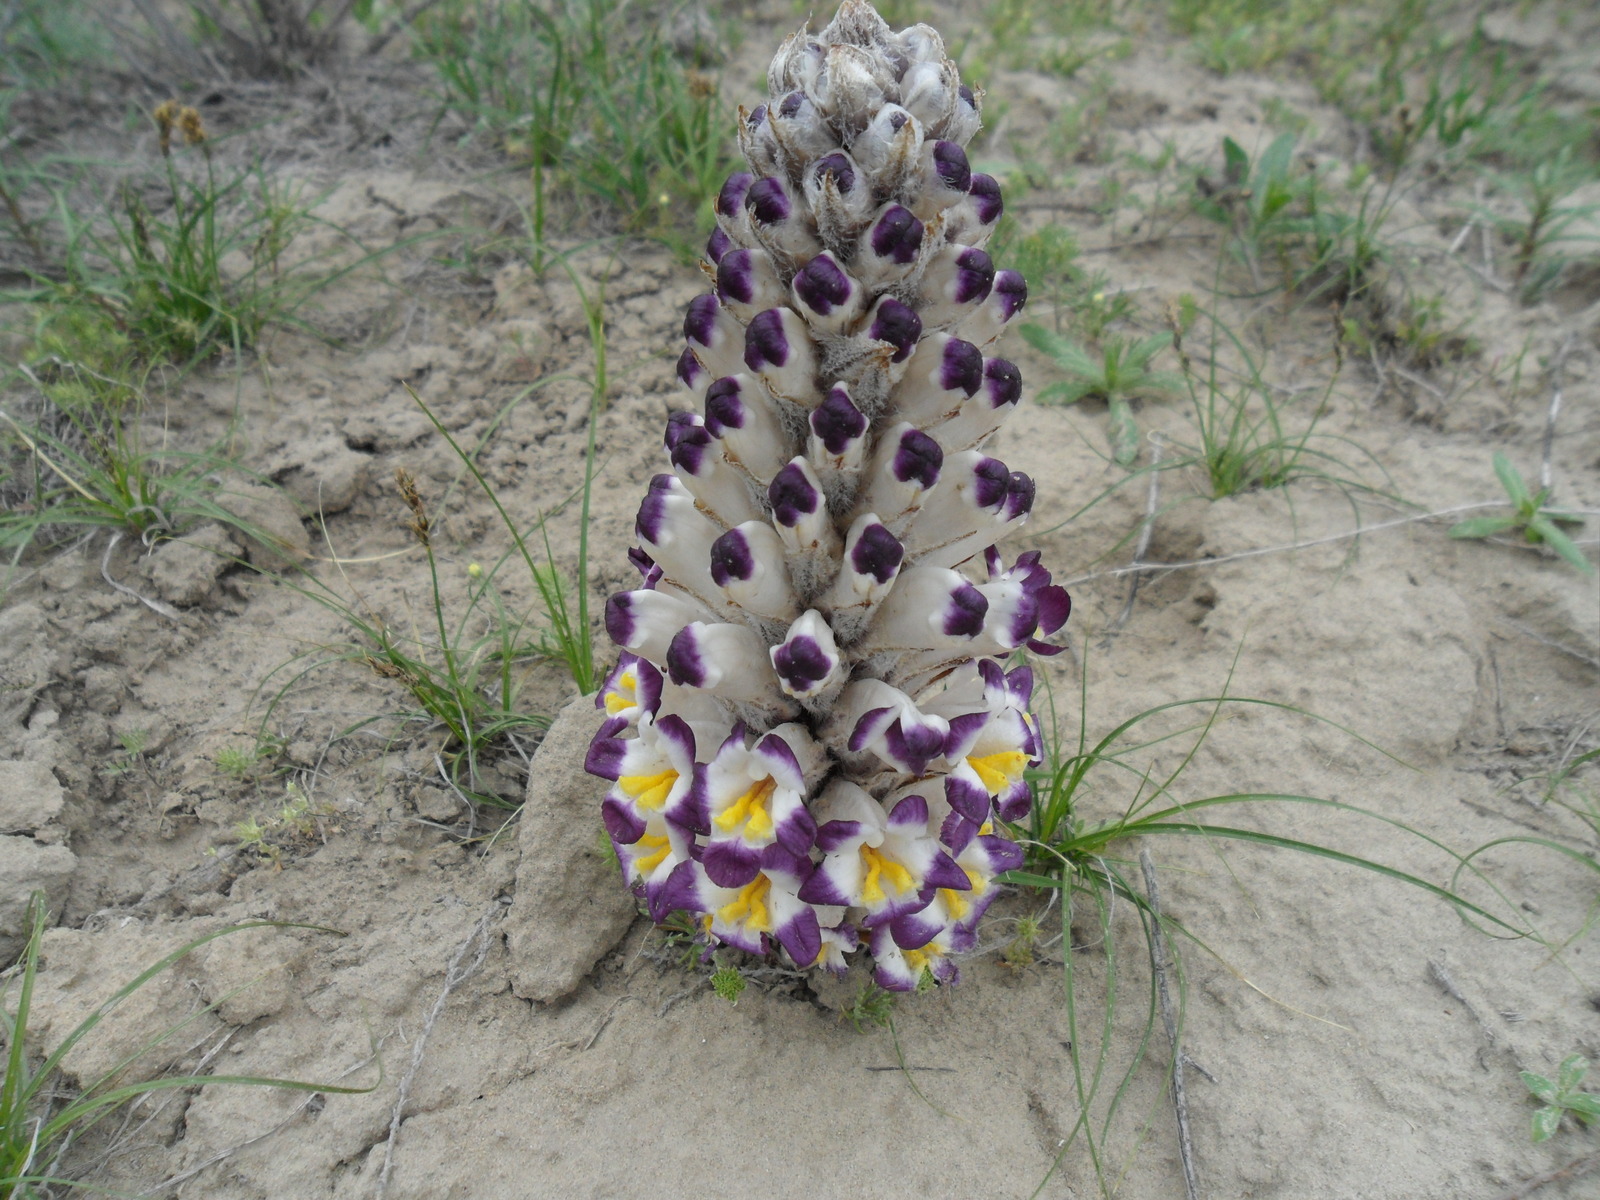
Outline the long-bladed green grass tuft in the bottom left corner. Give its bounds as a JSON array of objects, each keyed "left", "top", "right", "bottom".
[{"left": 0, "top": 891, "right": 382, "bottom": 1200}]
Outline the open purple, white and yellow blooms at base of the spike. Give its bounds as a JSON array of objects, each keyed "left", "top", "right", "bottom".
[{"left": 586, "top": 652, "right": 1048, "bottom": 990}]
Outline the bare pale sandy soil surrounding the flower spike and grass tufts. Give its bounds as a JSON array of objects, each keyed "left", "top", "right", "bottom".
[{"left": 0, "top": 5, "right": 1600, "bottom": 1200}]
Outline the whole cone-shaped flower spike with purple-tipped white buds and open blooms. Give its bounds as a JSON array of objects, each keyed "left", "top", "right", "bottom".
[{"left": 587, "top": 0, "right": 1070, "bottom": 990}]
